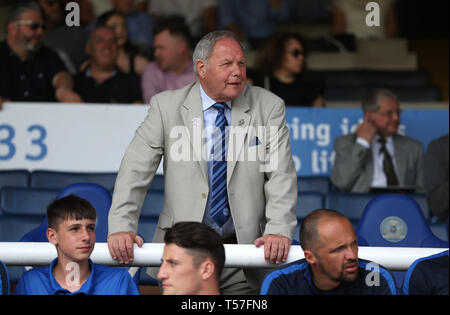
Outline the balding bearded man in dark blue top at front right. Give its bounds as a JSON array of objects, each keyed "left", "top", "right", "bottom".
[{"left": 261, "top": 209, "right": 396, "bottom": 295}]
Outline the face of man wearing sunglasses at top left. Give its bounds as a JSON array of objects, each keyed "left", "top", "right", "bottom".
[{"left": 12, "top": 11, "right": 44, "bottom": 52}]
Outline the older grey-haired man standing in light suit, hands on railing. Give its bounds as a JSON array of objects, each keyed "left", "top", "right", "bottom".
[{"left": 108, "top": 31, "right": 297, "bottom": 294}]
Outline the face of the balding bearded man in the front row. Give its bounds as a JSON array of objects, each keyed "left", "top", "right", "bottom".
[{"left": 314, "top": 219, "right": 359, "bottom": 287}]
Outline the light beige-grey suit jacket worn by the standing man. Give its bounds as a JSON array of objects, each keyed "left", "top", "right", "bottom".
[{"left": 109, "top": 82, "right": 297, "bottom": 288}]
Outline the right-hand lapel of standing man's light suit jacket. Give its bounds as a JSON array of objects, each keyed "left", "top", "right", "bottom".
[{"left": 227, "top": 92, "right": 252, "bottom": 183}]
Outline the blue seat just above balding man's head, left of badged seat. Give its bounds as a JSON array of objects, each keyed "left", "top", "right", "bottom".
[{"left": 325, "top": 192, "right": 377, "bottom": 226}]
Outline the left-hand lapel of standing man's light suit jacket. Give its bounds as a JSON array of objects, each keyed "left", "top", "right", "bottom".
[{"left": 181, "top": 81, "right": 208, "bottom": 182}]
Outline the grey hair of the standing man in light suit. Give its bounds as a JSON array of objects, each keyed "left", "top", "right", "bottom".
[{"left": 192, "top": 31, "right": 244, "bottom": 75}]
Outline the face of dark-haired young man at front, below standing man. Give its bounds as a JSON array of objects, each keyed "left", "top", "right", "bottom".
[{"left": 158, "top": 244, "right": 201, "bottom": 295}]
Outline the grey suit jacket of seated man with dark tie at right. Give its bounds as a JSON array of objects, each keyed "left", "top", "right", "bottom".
[{"left": 331, "top": 133, "right": 425, "bottom": 193}]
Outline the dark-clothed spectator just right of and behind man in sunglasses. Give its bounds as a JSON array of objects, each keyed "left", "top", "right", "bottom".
[{"left": 39, "top": 0, "right": 89, "bottom": 74}]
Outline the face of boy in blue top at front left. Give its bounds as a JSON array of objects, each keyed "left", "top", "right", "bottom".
[{"left": 47, "top": 219, "right": 95, "bottom": 262}]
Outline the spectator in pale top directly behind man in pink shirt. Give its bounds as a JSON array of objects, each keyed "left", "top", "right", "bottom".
[{"left": 148, "top": 0, "right": 218, "bottom": 42}]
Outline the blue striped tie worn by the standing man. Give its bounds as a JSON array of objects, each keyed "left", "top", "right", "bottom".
[{"left": 210, "top": 103, "right": 230, "bottom": 226}]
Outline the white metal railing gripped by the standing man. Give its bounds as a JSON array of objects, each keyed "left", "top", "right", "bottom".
[{"left": 0, "top": 242, "right": 448, "bottom": 270}]
